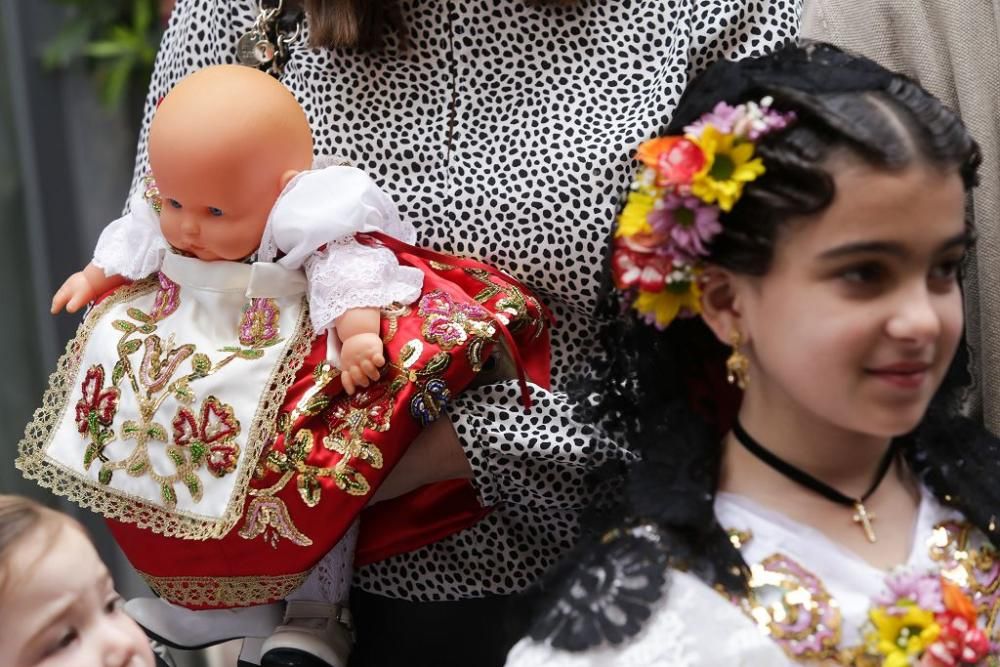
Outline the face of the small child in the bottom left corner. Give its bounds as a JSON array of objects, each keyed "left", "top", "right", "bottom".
[{"left": 0, "top": 524, "right": 154, "bottom": 667}]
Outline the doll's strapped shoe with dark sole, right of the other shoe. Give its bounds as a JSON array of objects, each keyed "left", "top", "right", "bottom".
[{"left": 260, "top": 600, "right": 354, "bottom": 667}]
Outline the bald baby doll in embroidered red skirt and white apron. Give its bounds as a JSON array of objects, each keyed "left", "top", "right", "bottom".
[{"left": 18, "top": 66, "right": 545, "bottom": 666}]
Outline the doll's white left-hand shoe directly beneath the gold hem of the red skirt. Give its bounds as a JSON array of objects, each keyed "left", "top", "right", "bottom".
[{"left": 125, "top": 598, "right": 282, "bottom": 650}]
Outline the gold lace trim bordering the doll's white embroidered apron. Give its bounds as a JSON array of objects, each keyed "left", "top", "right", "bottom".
[{"left": 15, "top": 277, "right": 313, "bottom": 540}]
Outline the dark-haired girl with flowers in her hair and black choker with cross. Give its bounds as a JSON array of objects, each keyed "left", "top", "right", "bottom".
[{"left": 508, "top": 44, "right": 1000, "bottom": 667}]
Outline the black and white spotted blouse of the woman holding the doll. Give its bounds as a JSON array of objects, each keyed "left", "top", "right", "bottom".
[{"left": 129, "top": 0, "right": 801, "bottom": 600}]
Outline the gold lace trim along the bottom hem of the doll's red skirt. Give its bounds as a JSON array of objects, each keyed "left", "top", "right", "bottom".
[{"left": 139, "top": 571, "right": 309, "bottom": 607}]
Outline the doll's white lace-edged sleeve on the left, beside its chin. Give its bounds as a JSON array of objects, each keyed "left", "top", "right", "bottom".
[{"left": 92, "top": 193, "right": 169, "bottom": 280}]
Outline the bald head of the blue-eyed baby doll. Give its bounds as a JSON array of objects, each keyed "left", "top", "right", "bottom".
[{"left": 149, "top": 65, "right": 312, "bottom": 260}]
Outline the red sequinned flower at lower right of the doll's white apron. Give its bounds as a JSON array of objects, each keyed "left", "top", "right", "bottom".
[{"left": 172, "top": 396, "right": 240, "bottom": 477}]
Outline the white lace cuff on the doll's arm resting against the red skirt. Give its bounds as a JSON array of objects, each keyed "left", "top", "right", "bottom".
[{"left": 304, "top": 237, "right": 424, "bottom": 331}]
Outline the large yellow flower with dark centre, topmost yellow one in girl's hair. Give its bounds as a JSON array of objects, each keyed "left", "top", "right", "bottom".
[{"left": 690, "top": 125, "right": 764, "bottom": 211}]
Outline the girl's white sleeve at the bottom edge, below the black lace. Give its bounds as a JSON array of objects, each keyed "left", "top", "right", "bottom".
[{"left": 506, "top": 571, "right": 794, "bottom": 667}]
